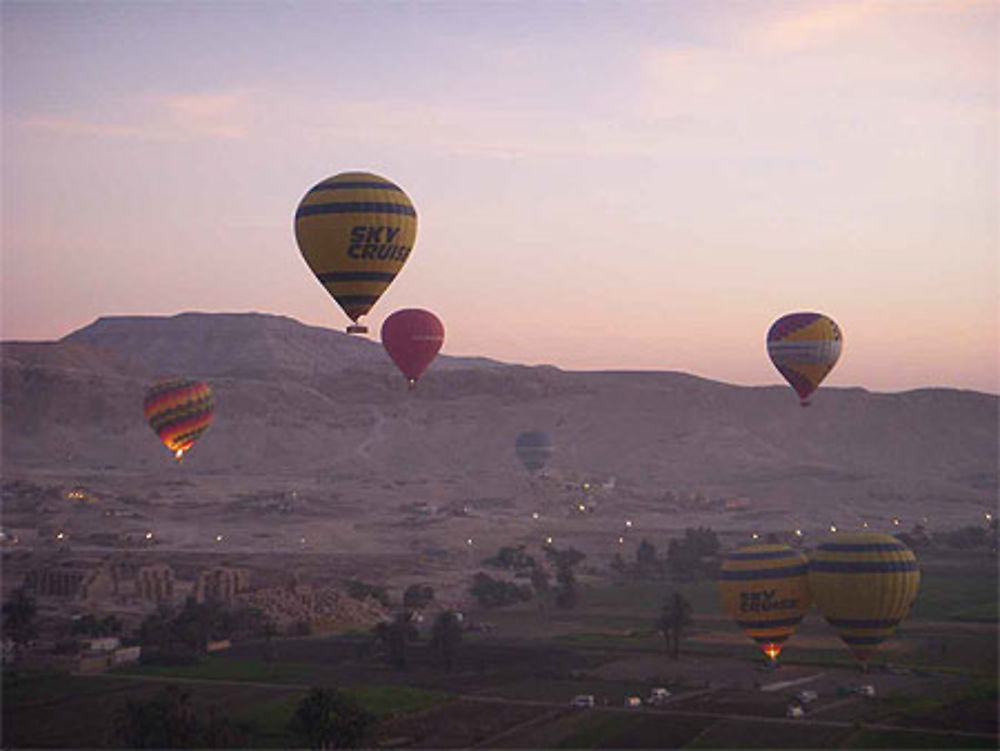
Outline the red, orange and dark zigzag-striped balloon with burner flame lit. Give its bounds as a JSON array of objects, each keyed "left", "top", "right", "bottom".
[{"left": 143, "top": 378, "right": 215, "bottom": 462}]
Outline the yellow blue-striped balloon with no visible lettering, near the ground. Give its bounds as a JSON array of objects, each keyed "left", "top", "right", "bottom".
[{"left": 809, "top": 532, "right": 920, "bottom": 667}]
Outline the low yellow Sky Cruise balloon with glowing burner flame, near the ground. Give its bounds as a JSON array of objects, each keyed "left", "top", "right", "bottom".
[{"left": 719, "top": 544, "right": 812, "bottom": 662}]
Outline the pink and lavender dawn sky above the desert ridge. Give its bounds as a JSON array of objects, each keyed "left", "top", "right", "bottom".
[{"left": 0, "top": 0, "right": 1000, "bottom": 392}]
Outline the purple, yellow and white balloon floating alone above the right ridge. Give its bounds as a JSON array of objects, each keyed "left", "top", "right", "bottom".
[{"left": 767, "top": 313, "right": 843, "bottom": 407}]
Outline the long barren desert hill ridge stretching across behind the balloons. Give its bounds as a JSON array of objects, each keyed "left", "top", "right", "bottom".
[{"left": 2, "top": 313, "right": 998, "bottom": 528}]
